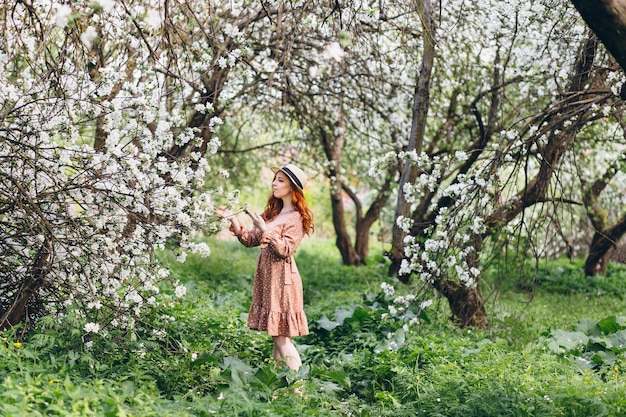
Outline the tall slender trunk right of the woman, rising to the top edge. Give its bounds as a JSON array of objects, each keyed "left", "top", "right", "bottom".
[{"left": 388, "top": 0, "right": 435, "bottom": 283}]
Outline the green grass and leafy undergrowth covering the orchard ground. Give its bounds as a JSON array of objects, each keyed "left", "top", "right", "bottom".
[{"left": 0, "top": 239, "right": 626, "bottom": 417}]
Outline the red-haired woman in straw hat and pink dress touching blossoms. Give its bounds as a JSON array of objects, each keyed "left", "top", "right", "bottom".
[{"left": 216, "top": 164, "right": 313, "bottom": 370}]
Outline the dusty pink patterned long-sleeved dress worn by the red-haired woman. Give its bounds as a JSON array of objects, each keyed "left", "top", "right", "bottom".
[{"left": 237, "top": 210, "right": 309, "bottom": 336}]
